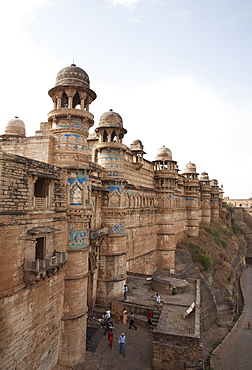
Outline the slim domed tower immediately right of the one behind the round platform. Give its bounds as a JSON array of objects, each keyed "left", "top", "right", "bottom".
[{"left": 183, "top": 161, "right": 199, "bottom": 236}]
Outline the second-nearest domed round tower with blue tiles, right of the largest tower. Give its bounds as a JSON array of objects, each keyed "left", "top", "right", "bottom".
[{"left": 95, "top": 110, "right": 127, "bottom": 305}]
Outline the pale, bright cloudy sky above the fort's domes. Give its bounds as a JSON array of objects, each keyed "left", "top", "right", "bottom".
[{"left": 0, "top": 0, "right": 252, "bottom": 199}]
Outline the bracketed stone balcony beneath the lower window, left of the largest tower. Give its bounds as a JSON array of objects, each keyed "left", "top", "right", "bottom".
[{"left": 24, "top": 251, "right": 67, "bottom": 284}]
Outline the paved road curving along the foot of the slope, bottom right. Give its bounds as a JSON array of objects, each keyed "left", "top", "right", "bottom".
[{"left": 211, "top": 266, "right": 252, "bottom": 370}]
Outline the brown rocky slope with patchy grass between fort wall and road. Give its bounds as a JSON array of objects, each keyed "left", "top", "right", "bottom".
[{"left": 176, "top": 209, "right": 252, "bottom": 331}]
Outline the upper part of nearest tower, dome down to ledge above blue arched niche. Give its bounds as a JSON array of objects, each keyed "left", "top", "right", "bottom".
[{"left": 48, "top": 64, "right": 96, "bottom": 167}]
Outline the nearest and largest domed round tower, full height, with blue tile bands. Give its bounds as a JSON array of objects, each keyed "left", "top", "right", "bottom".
[{"left": 48, "top": 64, "right": 96, "bottom": 369}]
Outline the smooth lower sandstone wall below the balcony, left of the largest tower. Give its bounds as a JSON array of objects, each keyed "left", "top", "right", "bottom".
[{"left": 0, "top": 271, "right": 64, "bottom": 370}]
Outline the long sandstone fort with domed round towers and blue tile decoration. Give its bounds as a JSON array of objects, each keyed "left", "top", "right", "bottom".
[{"left": 0, "top": 64, "right": 223, "bottom": 370}]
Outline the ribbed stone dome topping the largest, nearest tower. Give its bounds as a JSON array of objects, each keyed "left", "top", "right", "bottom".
[{"left": 55, "top": 64, "right": 90, "bottom": 88}]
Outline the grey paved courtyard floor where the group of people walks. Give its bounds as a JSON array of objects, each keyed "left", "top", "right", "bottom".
[{"left": 85, "top": 318, "right": 152, "bottom": 370}]
